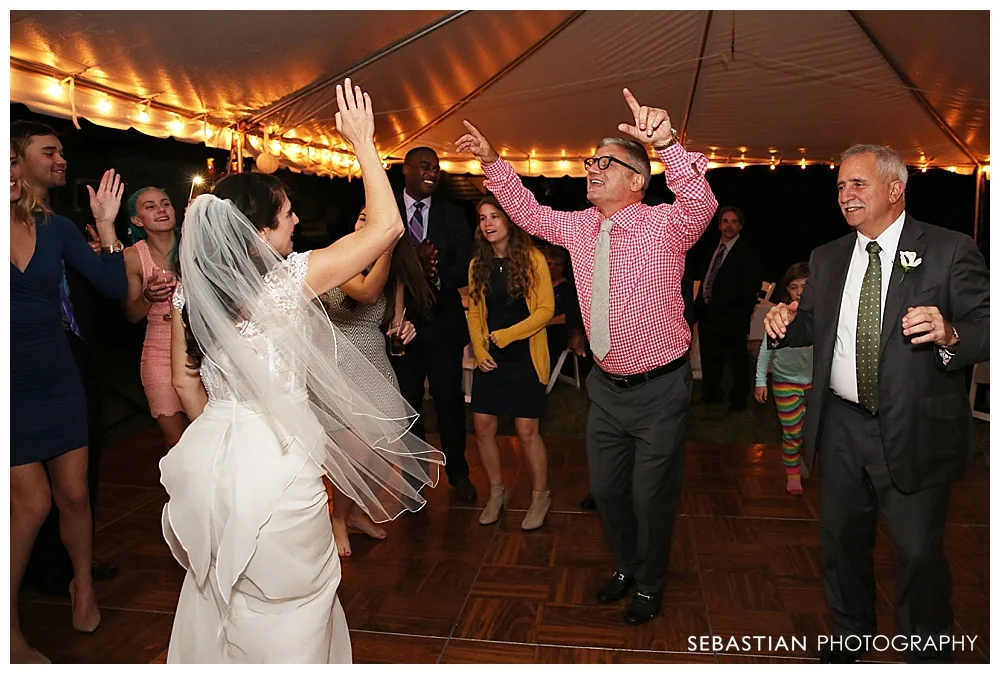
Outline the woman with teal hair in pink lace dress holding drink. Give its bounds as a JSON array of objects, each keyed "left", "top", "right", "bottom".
[{"left": 124, "top": 187, "right": 189, "bottom": 449}]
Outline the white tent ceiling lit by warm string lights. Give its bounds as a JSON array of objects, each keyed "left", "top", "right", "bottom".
[{"left": 10, "top": 10, "right": 990, "bottom": 176}]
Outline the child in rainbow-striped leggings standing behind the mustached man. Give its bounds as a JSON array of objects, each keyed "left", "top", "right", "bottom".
[{"left": 754, "top": 262, "right": 812, "bottom": 495}]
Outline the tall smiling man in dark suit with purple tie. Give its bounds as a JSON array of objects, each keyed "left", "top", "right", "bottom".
[{"left": 392, "top": 147, "right": 477, "bottom": 503}]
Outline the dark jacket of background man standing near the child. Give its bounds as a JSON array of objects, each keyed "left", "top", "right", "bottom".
[{"left": 694, "top": 236, "right": 761, "bottom": 338}]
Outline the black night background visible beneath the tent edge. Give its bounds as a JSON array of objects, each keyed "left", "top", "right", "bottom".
[{"left": 11, "top": 104, "right": 989, "bottom": 422}]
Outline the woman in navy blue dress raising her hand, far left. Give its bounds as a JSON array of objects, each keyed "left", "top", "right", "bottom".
[{"left": 10, "top": 145, "right": 128, "bottom": 663}]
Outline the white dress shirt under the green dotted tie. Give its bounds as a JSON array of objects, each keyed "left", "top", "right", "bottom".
[{"left": 830, "top": 211, "right": 906, "bottom": 403}]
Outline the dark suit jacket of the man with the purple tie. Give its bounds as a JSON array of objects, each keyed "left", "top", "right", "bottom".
[{"left": 396, "top": 192, "right": 472, "bottom": 346}]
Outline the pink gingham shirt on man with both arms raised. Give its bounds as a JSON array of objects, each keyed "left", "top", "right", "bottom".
[{"left": 483, "top": 144, "right": 719, "bottom": 375}]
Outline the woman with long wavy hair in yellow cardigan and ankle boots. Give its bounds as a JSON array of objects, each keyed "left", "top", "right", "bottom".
[{"left": 468, "top": 196, "right": 555, "bottom": 531}]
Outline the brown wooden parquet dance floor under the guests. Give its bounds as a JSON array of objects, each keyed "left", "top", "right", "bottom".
[{"left": 21, "top": 427, "right": 990, "bottom": 663}]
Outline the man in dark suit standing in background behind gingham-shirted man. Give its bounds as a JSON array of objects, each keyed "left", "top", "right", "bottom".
[{"left": 693, "top": 206, "right": 760, "bottom": 412}]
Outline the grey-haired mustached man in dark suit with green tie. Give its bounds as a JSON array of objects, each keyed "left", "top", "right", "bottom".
[{"left": 764, "top": 145, "right": 990, "bottom": 662}]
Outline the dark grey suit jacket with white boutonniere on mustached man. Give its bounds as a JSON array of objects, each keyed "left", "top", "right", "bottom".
[{"left": 775, "top": 216, "right": 990, "bottom": 493}]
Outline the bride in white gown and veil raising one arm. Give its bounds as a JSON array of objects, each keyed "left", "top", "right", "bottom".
[{"left": 160, "top": 80, "right": 444, "bottom": 663}]
